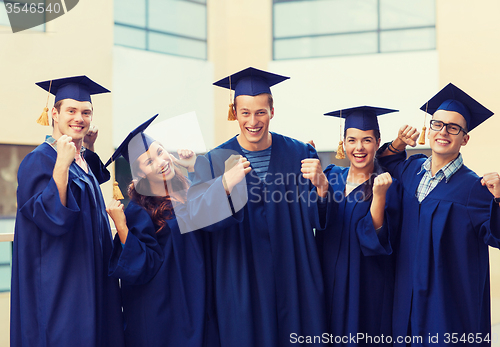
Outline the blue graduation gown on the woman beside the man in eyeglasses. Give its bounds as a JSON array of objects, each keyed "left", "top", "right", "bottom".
[{"left": 311, "top": 164, "right": 401, "bottom": 346}]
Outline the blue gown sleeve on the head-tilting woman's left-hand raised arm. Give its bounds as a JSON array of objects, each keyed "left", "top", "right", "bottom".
[{"left": 109, "top": 203, "right": 168, "bottom": 285}]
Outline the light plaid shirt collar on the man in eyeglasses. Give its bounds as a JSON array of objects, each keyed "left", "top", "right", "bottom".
[{"left": 416, "top": 154, "right": 464, "bottom": 203}]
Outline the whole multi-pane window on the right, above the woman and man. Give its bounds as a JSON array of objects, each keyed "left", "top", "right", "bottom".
[{"left": 273, "top": 0, "right": 436, "bottom": 60}]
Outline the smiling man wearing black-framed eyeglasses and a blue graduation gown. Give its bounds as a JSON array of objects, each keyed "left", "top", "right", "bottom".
[{"left": 379, "top": 83, "right": 500, "bottom": 346}]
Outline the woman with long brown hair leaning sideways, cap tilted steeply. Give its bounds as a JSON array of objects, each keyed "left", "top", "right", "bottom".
[{"left": 107, "top": 117, "right": 218, "bottom": 347}]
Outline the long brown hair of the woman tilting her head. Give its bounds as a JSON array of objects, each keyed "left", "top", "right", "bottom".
[{"left": 128, "top": 165, "right": 189, "bottom": 232}]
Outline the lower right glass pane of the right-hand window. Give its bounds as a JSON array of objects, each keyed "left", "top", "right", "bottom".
[{"left": 380, "top": 28, "right": 436, "bottom": 52}]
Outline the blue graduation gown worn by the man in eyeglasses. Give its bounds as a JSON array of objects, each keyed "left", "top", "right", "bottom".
[{"left": 379, "top": 144, "right": 500, "bottom": 346}]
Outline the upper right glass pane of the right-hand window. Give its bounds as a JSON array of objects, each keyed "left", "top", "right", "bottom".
[{"left": 380, "top": 0, "right": 436, "bottom": 29}]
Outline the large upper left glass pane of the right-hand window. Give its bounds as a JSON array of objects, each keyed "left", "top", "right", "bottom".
[{"left": 274, "top": 0, "right": 377, "bottom": 38}]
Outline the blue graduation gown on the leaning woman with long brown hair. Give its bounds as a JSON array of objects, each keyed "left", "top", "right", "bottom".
[{"left": 110, "top": 201, "right": 219, "bottom": 347}]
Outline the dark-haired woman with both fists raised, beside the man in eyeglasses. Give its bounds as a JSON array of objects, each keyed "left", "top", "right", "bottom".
[{"left": 302, "top": 106, "right": 401, "bottom": 346}]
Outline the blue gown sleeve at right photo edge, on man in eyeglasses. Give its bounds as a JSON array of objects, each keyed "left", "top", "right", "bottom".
[{"left": 467, "top": 178, "right": 500, "bottom": 248}]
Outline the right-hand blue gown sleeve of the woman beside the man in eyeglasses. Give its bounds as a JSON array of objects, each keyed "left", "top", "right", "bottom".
[{"left": 356, "top": 180, "right": 402, "bottom": 256}]
